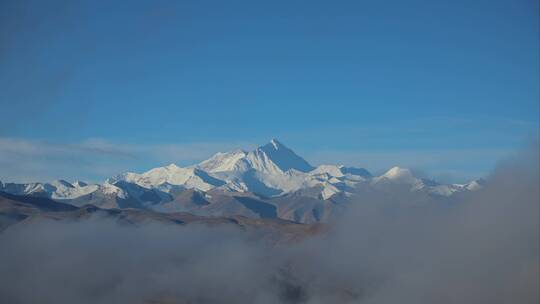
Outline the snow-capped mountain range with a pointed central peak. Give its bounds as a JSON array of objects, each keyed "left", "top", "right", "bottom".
[{"left": 0, "top": 139, "right": 483, "bottom": 222}]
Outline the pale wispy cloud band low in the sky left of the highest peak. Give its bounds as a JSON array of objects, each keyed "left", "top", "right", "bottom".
[{"left": 0, "top": 137, "right": 253, "bottom": 182}]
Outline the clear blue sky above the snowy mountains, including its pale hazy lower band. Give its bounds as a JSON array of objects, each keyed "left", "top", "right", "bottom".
[{"left": 0, "top": 0, "right": 540, "bottom": 180}]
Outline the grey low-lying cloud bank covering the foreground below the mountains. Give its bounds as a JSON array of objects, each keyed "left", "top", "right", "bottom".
[{"left": 0, "top": 142, "right": 540, "bottom": 304}]
